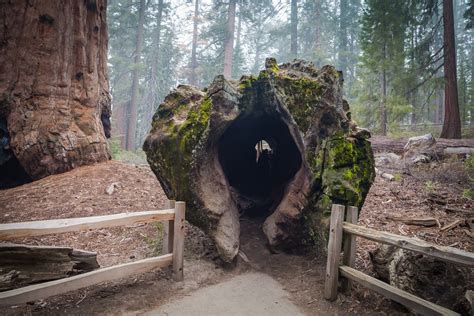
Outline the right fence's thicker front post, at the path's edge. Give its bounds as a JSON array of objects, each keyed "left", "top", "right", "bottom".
[{"left": 324, "top": 204, "right": 345, "bottom": 301}]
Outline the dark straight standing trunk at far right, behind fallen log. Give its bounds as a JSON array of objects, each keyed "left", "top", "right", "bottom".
[{"left": 441, "top": 0, "right": 461, "bottom": 138}]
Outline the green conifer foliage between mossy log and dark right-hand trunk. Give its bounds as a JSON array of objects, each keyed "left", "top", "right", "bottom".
[{"left": 355, "top": 0, "right": 410, "bottom": 128}]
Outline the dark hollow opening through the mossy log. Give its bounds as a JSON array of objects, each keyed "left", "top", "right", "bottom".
[{"left": 218, "top": 114, "right": 302, "bottom": 217}]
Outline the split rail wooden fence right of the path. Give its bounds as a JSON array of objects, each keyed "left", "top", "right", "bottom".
[{"left": 324, "top": 204, "right": 474, "bottom": 315}]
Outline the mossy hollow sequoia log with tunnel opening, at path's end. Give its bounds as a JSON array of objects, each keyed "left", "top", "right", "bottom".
[{"left": 144, "top": 59, "right": 375, "bottom": 261}]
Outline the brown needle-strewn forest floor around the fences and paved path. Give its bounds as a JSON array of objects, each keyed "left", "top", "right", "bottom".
[{"left": 0, "top": 138, "right": 474, "bottom": 315}]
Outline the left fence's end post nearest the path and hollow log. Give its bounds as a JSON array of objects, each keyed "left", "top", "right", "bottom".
[{"left": 173, "top": 202, "right": 186, "bottom": 281}]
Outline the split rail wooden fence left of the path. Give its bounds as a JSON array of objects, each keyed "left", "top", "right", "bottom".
[{"left": 0, "top": 201, "right": 185, "bottom": 306}]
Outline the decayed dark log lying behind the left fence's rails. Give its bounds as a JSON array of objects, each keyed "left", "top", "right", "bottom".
[{"left": 0, "top": 244, "right": 99, "bottom": 291}]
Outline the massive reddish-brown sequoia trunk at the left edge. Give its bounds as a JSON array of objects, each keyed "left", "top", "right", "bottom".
[{"left": 0, "top": 0, "right": 110, "bottom": 187}]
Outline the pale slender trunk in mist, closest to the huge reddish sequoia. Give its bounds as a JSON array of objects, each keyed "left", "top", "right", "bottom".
[{"left": 125, "top": 0, "right": 146, "bottom": 150}]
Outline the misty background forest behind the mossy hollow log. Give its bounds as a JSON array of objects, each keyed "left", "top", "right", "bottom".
[{"left": 107, "top": 0, "right": 474, "bottom": 150}]
